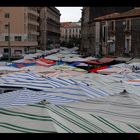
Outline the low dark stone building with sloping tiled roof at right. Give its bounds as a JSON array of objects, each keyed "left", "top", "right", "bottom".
[{"left": 95, "top": 7, "right": 140, "bottom": 58}]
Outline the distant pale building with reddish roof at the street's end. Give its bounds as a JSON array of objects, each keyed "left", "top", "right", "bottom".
[{"left": 60, "top": 22, "right": 81, "bottom": 42}]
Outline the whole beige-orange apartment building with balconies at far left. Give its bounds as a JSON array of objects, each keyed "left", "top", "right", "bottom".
[{"left": 0, "top": 7, "right": 39, "bottom": 58}]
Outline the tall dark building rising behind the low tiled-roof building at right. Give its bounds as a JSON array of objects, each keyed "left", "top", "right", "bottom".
[{"left": 79, "top": 7, "right": 132, "bottom": 56}]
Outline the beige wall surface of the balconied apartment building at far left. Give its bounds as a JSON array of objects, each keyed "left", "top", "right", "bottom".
[{"left": 0, "top": 7, "right": 39, "bottom": 54}]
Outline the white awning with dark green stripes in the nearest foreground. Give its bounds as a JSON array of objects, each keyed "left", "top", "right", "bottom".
[{"left": 0, "top": 99, "right": 140, "bottom": 133}]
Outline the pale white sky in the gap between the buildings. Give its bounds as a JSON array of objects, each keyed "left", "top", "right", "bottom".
[{"left": 56, "top": 7, "right": 82, "bottom": 22}]
